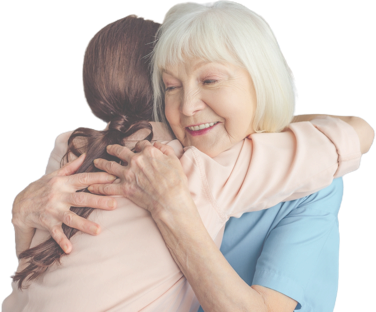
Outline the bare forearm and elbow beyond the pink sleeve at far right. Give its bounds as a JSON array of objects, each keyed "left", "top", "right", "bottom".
[{"left": 292, "top": 114, "right": 375, "bottom": 155}]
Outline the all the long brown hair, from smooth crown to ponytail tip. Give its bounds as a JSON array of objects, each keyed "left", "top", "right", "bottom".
[{"left": 13, "top": 14, "right": 160, "bottom": 289}]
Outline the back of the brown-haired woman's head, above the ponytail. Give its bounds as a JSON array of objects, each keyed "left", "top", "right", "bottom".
[{"left": 82, "top": 14, "right": 160, "bottom": 124}]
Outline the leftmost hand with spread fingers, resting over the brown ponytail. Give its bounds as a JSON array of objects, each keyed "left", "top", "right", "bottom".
[{"left": 12, "top": 155, "right": 116, "bottom": 255}]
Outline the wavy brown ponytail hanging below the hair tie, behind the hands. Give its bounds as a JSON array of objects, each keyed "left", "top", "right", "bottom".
[{"left": 13, "top": 116, "right": 153, "bottom": 289}]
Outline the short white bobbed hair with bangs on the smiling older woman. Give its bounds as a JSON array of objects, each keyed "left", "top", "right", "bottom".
[{"left": 151, "top": 0, "right": 298, "bottom": 132}]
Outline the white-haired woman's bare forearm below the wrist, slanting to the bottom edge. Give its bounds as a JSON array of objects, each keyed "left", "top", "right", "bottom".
[{"left": 155, "top": 209, "right": 267, "bottom": 312}]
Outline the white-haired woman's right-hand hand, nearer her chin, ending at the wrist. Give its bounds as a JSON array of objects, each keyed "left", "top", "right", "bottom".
[{"left": 89, "top": 141, "right": 193, "bottom": 219}]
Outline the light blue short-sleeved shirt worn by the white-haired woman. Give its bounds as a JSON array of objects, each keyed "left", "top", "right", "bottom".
[{"left": 199, "top": 178, "right": 344, "bottom": 312}]
